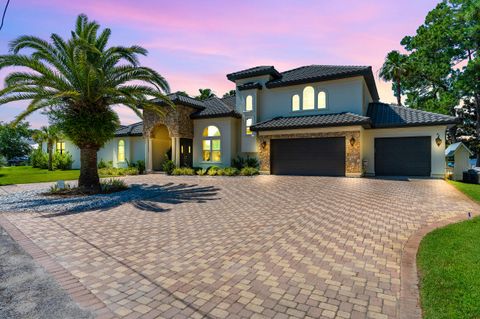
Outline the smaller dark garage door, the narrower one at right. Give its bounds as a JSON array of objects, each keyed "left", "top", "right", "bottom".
[{"left": 375, "top": 136, "right": 431, "bottom": 176}]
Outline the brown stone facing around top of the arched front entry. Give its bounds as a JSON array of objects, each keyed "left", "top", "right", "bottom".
[{"left": 143, "top": 105, "right": 195, "bottom": 138}]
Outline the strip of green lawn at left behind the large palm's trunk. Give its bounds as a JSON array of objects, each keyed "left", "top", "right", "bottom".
[{"left": 0, "top": 166, "right": 80, "bottom": 185}]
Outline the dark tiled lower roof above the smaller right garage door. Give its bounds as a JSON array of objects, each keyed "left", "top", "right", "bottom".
[{"left": 367, "top": 102, "right": 458, "bottom": 128}]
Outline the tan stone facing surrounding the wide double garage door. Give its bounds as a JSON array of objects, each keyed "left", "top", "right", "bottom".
[{"left": 257, "top": 131, "right": 362, "bottom": 176}]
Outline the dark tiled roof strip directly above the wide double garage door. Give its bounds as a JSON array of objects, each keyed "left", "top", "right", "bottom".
[{"left": 251, "top": 113, "right": 370, "bottom": 131}]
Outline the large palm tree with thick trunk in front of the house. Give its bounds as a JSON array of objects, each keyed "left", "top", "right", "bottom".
[{"left": 0, "top": 15, "right": 173, "bottom": 193}]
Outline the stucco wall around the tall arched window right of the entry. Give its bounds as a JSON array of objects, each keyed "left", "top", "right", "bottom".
[{"left": 193, "top": 117, "right": 239, "bottom": 168}]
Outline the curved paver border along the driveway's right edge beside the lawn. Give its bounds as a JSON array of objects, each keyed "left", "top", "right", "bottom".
[{"left": 398, "top": 184, "right": 480, "bottom": 319}]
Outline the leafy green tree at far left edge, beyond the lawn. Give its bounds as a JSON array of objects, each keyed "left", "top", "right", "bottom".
[{"left": 0, "top": 122, "right": 31, "bottom": 160}]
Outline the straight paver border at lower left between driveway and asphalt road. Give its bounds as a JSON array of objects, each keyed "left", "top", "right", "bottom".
[{"left": 0, "top": 215, "right": 114, "bottom": 319}]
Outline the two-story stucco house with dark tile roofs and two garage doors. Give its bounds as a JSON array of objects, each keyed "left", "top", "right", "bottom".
[{"left": 53, "top": 65, "right": 457, "bottom": 177}]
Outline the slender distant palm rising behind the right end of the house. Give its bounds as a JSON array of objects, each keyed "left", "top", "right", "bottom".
[{"left": 380, "top": 50, "right": 407, "bottom": 105}]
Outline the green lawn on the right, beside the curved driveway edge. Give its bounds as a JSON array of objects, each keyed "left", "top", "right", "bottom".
[{"left": 417, "top": 181, "right": 480, "bottom": 319}]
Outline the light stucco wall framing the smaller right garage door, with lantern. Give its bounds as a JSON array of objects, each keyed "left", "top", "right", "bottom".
[{"left": 361, "top": 126, "right": 446, "bottom": 177}]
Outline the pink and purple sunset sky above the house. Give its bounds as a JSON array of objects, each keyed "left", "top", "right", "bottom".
[{"left": 0, "top": 0, "right": 439, "bottom": 127}]
